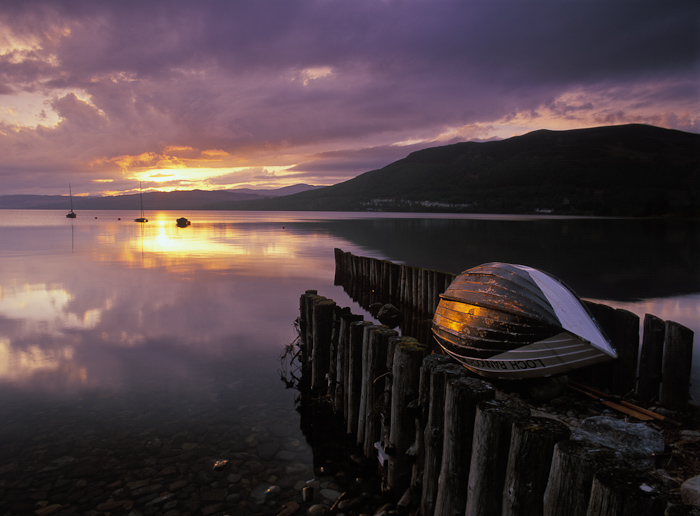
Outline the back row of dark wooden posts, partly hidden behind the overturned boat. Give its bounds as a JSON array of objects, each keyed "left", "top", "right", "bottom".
[{"left": 335, "top": 249, "right": 693, "bottom": 411}]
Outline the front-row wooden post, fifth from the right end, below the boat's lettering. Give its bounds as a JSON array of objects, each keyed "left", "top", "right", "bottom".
[{"left": 435, "top": 377, "right": 496, "bottom": 516}]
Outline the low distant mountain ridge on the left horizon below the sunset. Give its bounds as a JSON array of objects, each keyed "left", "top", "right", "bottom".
[{"left": 0, "top": 184, "right": 323, "bottom": 211}]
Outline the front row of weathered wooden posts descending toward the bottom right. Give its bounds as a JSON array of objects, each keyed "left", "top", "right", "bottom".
[{"left": 299, "top": 290, "right": 667, "bottom": 516}]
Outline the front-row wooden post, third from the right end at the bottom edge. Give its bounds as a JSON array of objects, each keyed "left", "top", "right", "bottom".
[{"left": 502, "top": 417, "right": 571, "bottom": 516}]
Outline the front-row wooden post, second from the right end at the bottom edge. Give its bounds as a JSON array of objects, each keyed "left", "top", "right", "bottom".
[{"left": 543, "top": 441, "right": 620, "bottom": 516}]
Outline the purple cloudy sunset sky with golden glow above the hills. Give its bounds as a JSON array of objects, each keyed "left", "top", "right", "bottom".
[{"left": 0, "top": 0, "right": 700, "bottom": 195}]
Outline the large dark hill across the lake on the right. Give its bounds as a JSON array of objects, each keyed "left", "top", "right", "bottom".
[{"left": 220, "top": 124, "right": 700, "bottom": 216}]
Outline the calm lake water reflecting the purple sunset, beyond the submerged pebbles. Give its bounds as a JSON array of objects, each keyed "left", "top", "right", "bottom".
[{"left": 0, "top": 210, "right": 700, "bottom": 512}]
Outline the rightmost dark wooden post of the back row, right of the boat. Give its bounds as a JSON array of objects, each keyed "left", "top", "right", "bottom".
[{"left": 661, "top": 321, "right": 693, "bottom": 410}]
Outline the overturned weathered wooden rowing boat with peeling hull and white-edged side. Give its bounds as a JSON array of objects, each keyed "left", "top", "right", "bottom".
[{"left": 432, "top": 263, "right": 617, "bottom": 378}]
